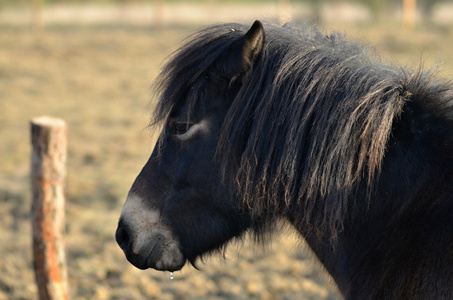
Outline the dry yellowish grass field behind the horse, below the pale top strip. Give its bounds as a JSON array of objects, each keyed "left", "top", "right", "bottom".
[{"left": 0, "top": 2, "right": 453, "bottom": 300}]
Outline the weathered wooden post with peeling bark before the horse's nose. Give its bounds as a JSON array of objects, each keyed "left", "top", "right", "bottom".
[{"left": 31, "top": 117, "right": 69, "bottom": 300}]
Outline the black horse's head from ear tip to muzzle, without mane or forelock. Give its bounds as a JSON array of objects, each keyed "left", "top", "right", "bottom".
[{"left": 116, "top": 22, "right": 264, "bottom": 271}]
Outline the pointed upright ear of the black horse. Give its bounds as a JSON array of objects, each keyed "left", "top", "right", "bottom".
[{"left": 221, "top": 20, "right": 264, "bottom": 85}]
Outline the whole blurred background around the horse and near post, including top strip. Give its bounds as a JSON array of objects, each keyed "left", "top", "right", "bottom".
[{"left": 0, "top": 0, "right": 453, "bottom": 299}]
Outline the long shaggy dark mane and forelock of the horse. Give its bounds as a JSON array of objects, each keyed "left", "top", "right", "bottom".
[{"left": 154, "top": 24, "right": 444, "bottom": 236}]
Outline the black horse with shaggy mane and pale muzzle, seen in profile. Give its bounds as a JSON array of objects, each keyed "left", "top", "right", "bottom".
[{"left": 116, "top": 21, "right": 453, "bottom": 299}]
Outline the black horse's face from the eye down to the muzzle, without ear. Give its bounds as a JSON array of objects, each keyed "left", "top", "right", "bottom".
[{"left": 117, "top": 92, "right": 244, "bottom": 271}]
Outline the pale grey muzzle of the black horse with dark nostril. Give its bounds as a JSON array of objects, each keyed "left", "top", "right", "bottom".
[{"left": 115, "top": 194, "right": 186, "bottom": 271}]
